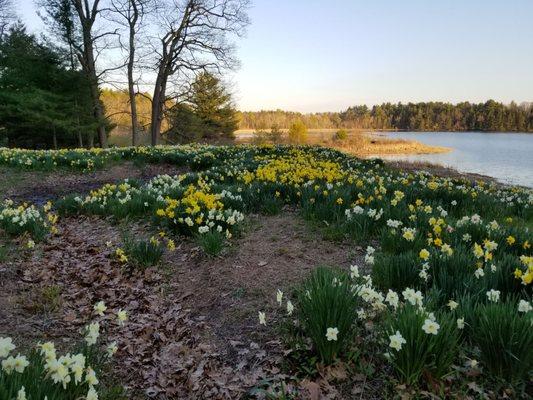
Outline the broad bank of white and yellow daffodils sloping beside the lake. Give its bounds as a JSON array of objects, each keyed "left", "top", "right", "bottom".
[{"left": 0, "top": 146, "right": 533, "bottom": 394}]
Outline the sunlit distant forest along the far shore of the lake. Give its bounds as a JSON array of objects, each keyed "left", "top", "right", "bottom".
[{"left": 239, "top": 100, "right": 533, "bottom": 132}]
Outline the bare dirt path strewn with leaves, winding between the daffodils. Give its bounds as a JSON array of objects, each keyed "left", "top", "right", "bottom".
[{"left": 0, "top": 211, "right": 362, "bottom": 399}]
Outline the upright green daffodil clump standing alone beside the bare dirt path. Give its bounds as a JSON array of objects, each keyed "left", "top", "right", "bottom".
[{"left": 298, "top": 267, "right": 357, "bottom": 364}]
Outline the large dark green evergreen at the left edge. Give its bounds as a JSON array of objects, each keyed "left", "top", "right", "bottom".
[{"left": 0, "top": 23, "right": 97, "bottom": 148}]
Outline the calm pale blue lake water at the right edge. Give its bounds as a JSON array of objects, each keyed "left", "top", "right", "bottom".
[{"left": 380, "top": 132, "right": 533, "bottom": 188}]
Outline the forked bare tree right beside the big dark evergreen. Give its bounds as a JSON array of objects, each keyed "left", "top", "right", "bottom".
[{"left": 40, "top": 0, "right": 120, "bottom": 147}]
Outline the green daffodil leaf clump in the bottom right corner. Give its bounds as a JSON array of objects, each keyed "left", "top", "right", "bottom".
[{"left": 472, "top": 301, "right": 533, "bottom": 383}]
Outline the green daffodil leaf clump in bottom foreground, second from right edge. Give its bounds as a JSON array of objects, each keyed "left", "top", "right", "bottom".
[{"left": 385, "top": 304, "right": 459, "bottom": 385}]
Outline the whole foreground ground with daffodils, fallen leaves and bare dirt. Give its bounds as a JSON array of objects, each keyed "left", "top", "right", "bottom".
[{"left": 0, "top": 146, "right": 533, "bottom": 399}]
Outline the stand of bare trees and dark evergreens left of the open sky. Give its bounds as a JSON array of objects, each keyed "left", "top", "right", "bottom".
[{"left": 0, "top": 0, "right": 249, "bottom": 147}]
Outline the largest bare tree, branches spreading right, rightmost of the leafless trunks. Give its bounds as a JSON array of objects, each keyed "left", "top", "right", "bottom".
[{"left": 150, "top": 0, "right": 249, "bottom": 146}]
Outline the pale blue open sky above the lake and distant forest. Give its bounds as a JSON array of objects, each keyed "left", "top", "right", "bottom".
[{"left": 14, "top": 0, "right": 533, "bottom": 112}]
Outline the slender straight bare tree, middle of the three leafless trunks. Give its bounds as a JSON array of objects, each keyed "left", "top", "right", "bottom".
[{"left": 111, "top": 0, "right": 151, "bottom": 146}]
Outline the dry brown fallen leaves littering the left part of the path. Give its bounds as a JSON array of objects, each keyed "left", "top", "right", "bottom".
[{"left": 8, "top": 217, "right": 285, "bottom": 399}]
